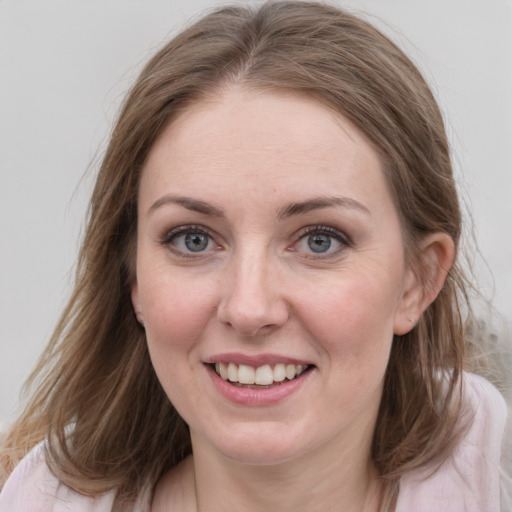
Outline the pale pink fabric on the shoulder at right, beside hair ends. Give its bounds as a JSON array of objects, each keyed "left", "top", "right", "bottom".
[{"left": 396, "top": 373, "right": 507, "bottom": 512}]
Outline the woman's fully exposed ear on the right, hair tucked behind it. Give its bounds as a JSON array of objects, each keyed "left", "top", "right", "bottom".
[{"left": 394, "top": 232, "right": 455, "bottom": 335}]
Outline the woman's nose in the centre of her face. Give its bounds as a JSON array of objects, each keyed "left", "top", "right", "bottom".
[{"left": 217, "top": 249, "right": 289, "bottom": 337}]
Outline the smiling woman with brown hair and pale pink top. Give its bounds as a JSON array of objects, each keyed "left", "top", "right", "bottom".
[{"left": 0, "top": 2, "right": 506, "bottom": 512}]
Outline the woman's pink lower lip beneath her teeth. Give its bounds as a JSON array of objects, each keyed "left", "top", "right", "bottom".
[{"left": 206, "top": 366, "right": 314, "bottom": 406}]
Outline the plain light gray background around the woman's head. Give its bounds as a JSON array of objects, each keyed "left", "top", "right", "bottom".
[{"left": 0, "top": 0, "right": 512, "bottom": 420}]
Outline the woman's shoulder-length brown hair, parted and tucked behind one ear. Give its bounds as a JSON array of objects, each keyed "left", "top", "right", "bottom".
[{"left": 2, "top": 1, "right": 472, "bottom": 510}]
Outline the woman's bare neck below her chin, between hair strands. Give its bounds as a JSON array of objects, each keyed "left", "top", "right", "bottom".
[{"left": 193, "top": 432, "right": 380, "bottom": 512}]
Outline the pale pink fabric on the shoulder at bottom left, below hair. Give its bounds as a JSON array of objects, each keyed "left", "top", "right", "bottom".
[{"left": 0, "top": 443, "right": 115, "bottom": 512}]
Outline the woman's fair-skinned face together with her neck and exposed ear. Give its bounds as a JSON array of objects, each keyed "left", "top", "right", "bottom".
[{"left": 132, "top": 87, "right": 453, "bottom": 512}]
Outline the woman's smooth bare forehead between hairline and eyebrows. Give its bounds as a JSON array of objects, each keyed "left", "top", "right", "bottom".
[{"left": 141, "top": 88, "right": 389, "bottom": 216}]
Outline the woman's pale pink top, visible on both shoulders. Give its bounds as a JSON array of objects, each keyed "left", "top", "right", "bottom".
[{"left": 0, "top": 374, "right": 512, "bottom": 512}]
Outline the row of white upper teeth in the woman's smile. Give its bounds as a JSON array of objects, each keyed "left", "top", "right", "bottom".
[{"left": 215, "top": 363, "right": 307, "bottom": 386}]
